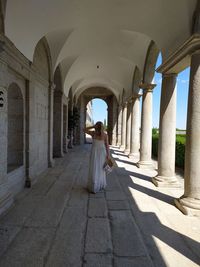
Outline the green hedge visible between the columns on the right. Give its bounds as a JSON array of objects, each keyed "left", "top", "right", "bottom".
[{"left": 152, "top": 134, "right": 186, "bottom": 168}]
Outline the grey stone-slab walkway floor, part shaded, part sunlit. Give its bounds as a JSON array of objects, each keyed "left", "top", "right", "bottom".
[{"left": 0, "top": 145, "right": 200, "bottom": 267}]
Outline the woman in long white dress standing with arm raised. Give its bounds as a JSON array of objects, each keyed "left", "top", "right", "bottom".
[{"left": 84, "top": 121, "right": 110, "bottom": 193}]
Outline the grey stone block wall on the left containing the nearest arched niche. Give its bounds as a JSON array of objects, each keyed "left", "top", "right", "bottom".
[{"left": 0, "top": 36, "right": 54, "bottom": 216}]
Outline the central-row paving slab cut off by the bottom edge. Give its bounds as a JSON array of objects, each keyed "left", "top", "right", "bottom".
[{"left": 83, "top": 254, "right": 112, "bottom": 267}]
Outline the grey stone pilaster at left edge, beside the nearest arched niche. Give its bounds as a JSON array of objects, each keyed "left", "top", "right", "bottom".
[{"left": 0, "top": 61, "right": 13, "bottom": 214}]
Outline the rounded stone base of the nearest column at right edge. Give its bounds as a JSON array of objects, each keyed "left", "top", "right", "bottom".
[{"left": 174, "top": 197, "right": 200, "bottom": 217}]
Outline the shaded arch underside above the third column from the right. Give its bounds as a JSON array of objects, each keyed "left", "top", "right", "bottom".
[{"left": 143, "top": 41, "right": 160, "bottom": 83}]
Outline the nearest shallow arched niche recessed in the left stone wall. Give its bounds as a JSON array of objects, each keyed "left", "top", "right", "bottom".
[{"left": 7, "top": 83, "right": 24, "bottom": 172}]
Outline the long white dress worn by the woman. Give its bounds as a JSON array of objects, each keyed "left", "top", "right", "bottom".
[{"left": 88, "top": 139, "right": 106, "bottom": 193}]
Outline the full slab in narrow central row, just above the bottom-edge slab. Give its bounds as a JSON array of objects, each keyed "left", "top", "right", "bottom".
[{"left": 85, "top": 218, "right": 112, "bottom": 253}]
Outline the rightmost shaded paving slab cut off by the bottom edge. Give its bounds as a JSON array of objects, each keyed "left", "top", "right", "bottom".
[{"left": 114, "top": 256, "right": 153, "bottom": 267}]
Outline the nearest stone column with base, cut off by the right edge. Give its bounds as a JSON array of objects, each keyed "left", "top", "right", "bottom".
[{"left": 175, "top": 51, "right": 200, "bottom": 216}]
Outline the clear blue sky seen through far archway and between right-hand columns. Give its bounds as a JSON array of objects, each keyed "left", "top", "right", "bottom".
[{"left": 92, "top": 55, "right": 190, "bottom": 130}]
